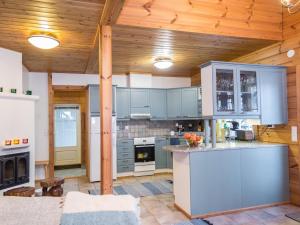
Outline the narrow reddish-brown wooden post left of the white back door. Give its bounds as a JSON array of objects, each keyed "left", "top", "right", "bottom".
[{"left": 48, "top": 72, "right": 54, "bottom": 177}]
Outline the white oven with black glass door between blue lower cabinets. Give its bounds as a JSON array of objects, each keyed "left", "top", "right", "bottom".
[{"left": 133, "top": 137, "right": 155, "bottom": 176}]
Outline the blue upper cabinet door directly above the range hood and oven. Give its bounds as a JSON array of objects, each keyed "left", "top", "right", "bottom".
[{"left": 130, "top": 88, "right": 150, "bottom": 114}]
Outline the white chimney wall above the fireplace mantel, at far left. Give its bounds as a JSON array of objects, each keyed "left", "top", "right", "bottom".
[{"left": 0, "top": 48, "right": 23, "bottom": 94}]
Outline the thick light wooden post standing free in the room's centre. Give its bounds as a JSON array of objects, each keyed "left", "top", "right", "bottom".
[{"left": 99, "top": 26, "right": 113, "bottom": 194}]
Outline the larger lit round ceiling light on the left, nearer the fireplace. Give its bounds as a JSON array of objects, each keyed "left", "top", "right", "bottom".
[{"left": 28, "top": 34, "right": 60, "bottom": 49}]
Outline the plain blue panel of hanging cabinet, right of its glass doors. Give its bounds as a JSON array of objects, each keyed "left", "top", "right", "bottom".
[{"left": 260, "top": 68, "right": 288, "bottom": 124}]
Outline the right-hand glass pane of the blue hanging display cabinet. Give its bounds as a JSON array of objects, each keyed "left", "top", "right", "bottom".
[{"left": 239, "top": 70, "right": 258, "bottom": 114}]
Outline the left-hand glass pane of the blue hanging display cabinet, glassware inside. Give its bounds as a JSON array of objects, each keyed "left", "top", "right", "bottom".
[{"left": 215, "top": 68, "right": 235, "bottom": 113}]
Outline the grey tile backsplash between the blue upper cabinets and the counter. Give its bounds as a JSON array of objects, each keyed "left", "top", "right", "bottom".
[{"left": 117, "top": 120, "right": 199, "bottom": 138}]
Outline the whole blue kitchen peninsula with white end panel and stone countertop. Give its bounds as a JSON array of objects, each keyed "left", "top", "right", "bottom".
[{"left": 164, "top": 142, "right": 289, "bottom": 218}]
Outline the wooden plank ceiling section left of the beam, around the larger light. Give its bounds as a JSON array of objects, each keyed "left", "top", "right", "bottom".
[{"left": 0, "top": 0, "right": 105, "bottom": 73}]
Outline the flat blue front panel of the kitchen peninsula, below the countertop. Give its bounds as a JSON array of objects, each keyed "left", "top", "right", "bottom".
[{"left": 189, "top": 146, "right": 289, "bottom": 215}]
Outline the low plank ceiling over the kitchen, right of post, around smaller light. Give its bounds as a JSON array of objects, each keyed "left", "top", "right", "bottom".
[{"left": 94, "top": 25, "right": 274, "bottom": 76}]
